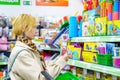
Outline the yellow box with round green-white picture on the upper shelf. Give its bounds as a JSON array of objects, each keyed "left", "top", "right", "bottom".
[{"left": 94, "top": 17, "right": 107, "bottom": 36}]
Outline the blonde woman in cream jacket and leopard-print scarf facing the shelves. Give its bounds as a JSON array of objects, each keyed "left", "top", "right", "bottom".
[{"left": 8, "top": 14, "right": 71, "bottom": 80}]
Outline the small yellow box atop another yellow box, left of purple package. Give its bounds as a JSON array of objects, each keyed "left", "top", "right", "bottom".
[{"left": 84, "top": 42, "right": 98, "bottom": 52}]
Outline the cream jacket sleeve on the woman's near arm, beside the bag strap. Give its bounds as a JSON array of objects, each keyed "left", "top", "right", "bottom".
[{"left": 13, "top": 51, "right": 45, "bottom": 80}]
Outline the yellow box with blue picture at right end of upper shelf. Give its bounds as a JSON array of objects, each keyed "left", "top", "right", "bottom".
[{"left": 107, "top": 20, "right": 120, "bottom": 36}]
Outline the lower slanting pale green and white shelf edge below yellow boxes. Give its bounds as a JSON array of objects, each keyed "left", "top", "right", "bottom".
[{"left": 67, "top": 59, "right": 120, "bottom": 76}]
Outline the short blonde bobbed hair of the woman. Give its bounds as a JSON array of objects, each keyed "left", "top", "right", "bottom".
[{"left": 12, "top": 14, "right": 36, "bottom": 35}]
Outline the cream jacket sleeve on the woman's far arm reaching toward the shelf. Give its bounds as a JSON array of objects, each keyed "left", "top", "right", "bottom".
[{"left": 45, "top": 56, "right": 66, "bottom": 78}]
